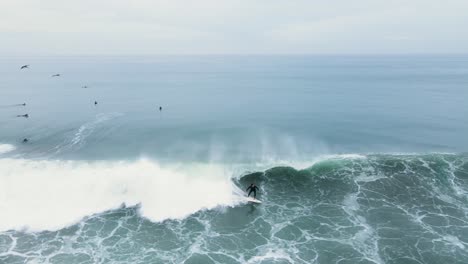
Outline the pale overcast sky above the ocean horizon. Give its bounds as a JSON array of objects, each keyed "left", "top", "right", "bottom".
[{"left": 0, "top": 0, "right": 468, "bottom": 55}]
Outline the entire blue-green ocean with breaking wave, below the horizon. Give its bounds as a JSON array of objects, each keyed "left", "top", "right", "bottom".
[{"left": 0, "top": 55, "right": 468, "bottom": 264}]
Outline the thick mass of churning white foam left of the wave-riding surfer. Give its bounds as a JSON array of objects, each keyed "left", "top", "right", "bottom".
[{"left": 0, "top": 159, "right": 239, "bottom": 230}]
